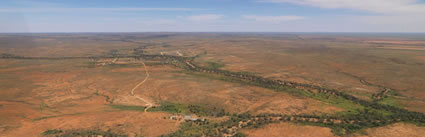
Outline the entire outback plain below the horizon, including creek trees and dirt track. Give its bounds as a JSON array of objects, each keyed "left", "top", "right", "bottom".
[{"left": 0, "top": 33, "right": 425, "bottom": 137}]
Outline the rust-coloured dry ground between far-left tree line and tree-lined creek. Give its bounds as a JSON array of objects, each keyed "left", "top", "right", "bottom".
[{"left": 0, "top": 57, "right": 341, "bottom": 136}]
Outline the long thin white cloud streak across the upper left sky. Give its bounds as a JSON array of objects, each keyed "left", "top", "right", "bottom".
[{"left": 0, "top": 8, "right": 203, "bottom": 12}]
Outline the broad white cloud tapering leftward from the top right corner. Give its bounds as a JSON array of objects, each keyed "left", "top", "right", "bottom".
[{"left": 260, "top": 0, "right": 425, "bottom": 14}]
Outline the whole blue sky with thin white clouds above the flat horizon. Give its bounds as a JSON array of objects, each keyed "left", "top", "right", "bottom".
[{"left": 0, "top": 0, "right": 425, "bottom": 33}]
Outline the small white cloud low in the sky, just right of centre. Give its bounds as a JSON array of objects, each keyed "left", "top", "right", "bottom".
[{"left": 243, "top": 15, "right": 304, "bottom": 23}]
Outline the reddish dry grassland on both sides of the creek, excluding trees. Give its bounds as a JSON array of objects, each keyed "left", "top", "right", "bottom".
[{"left": 0, "top": 34, "right": 425, "bottom": 136}]
